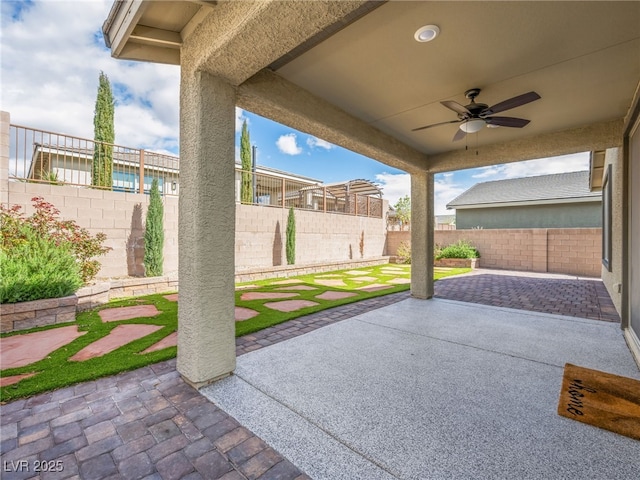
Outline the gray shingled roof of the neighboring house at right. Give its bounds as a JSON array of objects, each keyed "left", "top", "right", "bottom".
[{"left": 447, "top": 171, "right": 602, "bottom": 208}]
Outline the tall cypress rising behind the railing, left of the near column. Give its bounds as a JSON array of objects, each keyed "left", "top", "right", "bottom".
[{"left": 91, "top": 72, "right": 115, "bottom": 188}]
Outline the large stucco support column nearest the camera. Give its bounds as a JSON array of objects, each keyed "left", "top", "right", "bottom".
[{"left": 177, "top": 68, "right": 236, "bottom": 387}]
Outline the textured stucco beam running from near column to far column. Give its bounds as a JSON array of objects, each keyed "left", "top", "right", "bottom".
[{"left": 236, "top": 69, "right": 428, "bottom": 173}]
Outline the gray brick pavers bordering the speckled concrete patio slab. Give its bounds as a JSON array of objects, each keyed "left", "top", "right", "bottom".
[{"left": 0, "top": 274, "right": 619, "bottom": 480}]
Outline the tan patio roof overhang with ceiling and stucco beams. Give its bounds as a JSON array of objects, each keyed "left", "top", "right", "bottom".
[{"left": 104, "top": 0, "right": 640, "bottom": 172}]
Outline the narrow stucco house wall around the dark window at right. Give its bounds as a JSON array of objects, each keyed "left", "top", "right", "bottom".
[{"left": 601, "top": 148, "right": 623, "bottom": 312}]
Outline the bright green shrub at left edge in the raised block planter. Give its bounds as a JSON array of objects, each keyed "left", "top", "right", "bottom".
[{"left": 0, "top": 225, "right": 82, "bottom": 303}]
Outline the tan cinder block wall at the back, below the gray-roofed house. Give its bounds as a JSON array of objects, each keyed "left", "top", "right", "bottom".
[{"left": 386, "top": 228, "right": 602, "bottom": 277}]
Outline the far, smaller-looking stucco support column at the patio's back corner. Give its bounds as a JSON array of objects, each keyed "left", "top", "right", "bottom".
[{"left": 411, "top": 171, "right": 434, "bottom": 299}]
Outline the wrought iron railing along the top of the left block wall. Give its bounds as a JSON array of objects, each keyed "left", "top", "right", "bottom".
[{"left": 9, "top": 125, "right": 383, "bottom": 218}]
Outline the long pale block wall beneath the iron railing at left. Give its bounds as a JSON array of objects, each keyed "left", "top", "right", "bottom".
[{"left": 8, "top": 182, "right": 388, "bottom": 278}]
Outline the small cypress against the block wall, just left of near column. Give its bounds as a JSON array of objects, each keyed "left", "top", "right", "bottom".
[{"left": 144, "top": 178, "right": 164, "bottom": 277}]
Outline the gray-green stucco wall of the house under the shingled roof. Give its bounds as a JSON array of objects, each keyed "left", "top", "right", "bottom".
[{"left": 456, "top": 201, "right": 602, "bottom": 230}]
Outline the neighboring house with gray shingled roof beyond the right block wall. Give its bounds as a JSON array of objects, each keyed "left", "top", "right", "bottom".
[{"left": 447, "top": 171, "right": 602, "bottom": 230}]
